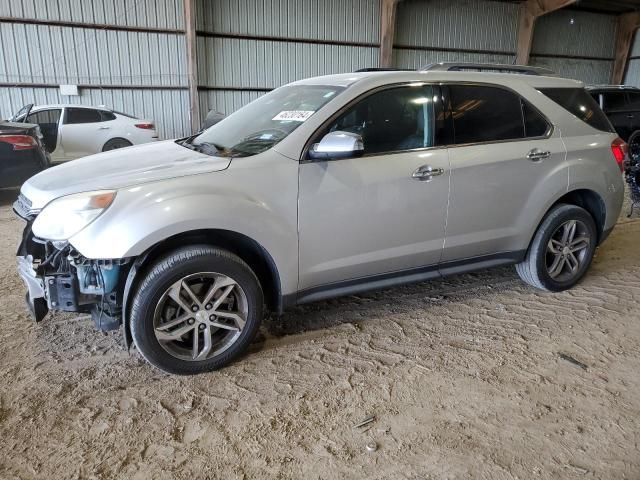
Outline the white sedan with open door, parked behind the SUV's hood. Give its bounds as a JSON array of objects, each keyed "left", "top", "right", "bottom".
[{"left": 12, "top": 104, "right": 158, "bottom": 163}]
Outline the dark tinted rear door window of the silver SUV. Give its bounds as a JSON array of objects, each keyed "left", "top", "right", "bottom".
[{"left": 448, "top": 85, "right": 524, "bottom": 145}]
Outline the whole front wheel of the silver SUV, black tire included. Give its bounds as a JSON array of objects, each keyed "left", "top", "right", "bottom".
[{"left": 130, "top": 245, "right": 263, "bottom": 375}]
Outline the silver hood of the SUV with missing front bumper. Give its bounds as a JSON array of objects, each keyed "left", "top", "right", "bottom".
[{"left": 21, "top": 140, "right": 231, "bottom": 210}]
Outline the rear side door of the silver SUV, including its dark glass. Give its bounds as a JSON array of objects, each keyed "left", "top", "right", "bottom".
[{"left": 442, "top": 85, "right": 568, "bottom": 267}]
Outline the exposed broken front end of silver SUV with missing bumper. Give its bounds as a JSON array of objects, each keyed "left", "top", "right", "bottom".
[{"left": 14, "top": 202, "right": 131, "bottom": 331}]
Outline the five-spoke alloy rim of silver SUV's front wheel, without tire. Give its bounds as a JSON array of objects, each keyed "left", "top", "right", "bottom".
[{"left": 153, "top": 272, "right": 248, "bottom": 361}]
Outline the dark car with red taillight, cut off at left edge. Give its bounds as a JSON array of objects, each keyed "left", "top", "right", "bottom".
[{"left": 0, "top": 122, "right": 50, "bottom": 188}]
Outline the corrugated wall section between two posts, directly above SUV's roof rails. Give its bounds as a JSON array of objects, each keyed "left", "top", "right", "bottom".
[{"left": 394, "top": 0, "right": 518, "bottom": 68}]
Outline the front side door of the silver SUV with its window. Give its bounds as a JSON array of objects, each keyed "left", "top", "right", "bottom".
[{"left": 298, "top": 85, "right": 449, "bottom": 290}]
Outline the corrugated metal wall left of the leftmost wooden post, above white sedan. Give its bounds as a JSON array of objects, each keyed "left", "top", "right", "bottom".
[{"left": 0, "top": 0, "right": 189, "bottom": 137}]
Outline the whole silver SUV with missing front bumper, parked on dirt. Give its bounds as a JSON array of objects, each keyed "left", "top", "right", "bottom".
[{"left": 14, "top": 64, "right": 626, "bottom": 374}]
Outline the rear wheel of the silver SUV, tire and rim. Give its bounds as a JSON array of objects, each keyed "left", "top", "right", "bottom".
[{"left": 516, "top": 204, "right": 598, "bottom": 292}]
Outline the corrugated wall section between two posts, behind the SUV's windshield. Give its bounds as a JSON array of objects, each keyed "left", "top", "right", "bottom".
[{"left": 197, "top": 0, "right": 380, "bottom": 119}]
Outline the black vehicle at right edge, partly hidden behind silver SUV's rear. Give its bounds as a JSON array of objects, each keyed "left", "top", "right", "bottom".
[{"left": 588, "top": 85, "right": 640, "bottom": 142}]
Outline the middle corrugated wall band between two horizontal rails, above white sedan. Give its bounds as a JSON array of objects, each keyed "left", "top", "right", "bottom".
[{"left": 0, "top": 22, "right": 186, "bottom": 86}]
